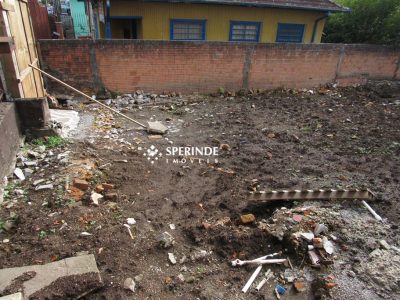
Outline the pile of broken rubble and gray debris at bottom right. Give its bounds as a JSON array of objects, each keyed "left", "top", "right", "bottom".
[{"left": 232, "top": 203, "right": 400, "bottom": 298}]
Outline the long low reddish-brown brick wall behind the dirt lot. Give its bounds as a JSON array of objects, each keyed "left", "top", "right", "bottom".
[{"left": 40, "top": 40, "right": 400, "bottom": 93}]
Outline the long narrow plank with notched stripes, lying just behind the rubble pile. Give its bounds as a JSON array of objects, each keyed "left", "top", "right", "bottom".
[{"left": 249, "top": 189, "right": 374, "bottom": 201}]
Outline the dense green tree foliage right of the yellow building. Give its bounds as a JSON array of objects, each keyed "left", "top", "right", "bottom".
[{"left": 322, "top": 0, "right": 400, "bottom": 45}]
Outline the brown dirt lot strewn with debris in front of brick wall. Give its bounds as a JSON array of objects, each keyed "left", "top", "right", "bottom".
[{"left": 0, "top": 82, "right": 400, "bottom": 299}]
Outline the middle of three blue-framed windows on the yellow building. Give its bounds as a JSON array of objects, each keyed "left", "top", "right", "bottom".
[{"left": 229, "top": 21, "right": 261, "bottom": 42}]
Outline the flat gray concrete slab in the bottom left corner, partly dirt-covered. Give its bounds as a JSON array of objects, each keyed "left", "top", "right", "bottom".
[{"left": 0, "top": 254, "right": 102, "bottom": 299}]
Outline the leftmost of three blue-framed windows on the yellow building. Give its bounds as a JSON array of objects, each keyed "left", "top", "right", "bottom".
[{"left": 170, "top": 19, "right": 206, "bottom": 40}]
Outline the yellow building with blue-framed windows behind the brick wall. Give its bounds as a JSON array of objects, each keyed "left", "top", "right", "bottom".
[{"left": 97, "top": 0, "right": 348, "bottom": 43}]
